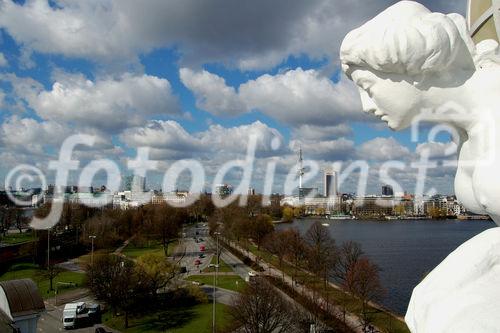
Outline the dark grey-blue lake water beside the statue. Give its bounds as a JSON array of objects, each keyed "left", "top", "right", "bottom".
[{"left": 277, "top": 219, "right": 496, "bottom": 315}]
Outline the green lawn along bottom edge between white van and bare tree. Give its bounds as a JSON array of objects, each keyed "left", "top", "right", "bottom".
[{"left": 102, "top": 303, "right": 228, "bottom": 333}]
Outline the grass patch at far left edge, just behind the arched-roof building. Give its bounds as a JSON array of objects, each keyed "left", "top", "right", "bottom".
[{"left": 0, "top": 263, "right": 85, "bottom": 298}]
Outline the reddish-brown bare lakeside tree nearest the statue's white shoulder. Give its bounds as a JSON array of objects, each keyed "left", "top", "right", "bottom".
[{"left": 345, "top": 257, "right": 384, "bottom": 332}]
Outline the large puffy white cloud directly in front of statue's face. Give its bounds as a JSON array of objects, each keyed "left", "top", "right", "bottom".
[{"left": 239, "top": 68, "right": 363, "bottom": 125}]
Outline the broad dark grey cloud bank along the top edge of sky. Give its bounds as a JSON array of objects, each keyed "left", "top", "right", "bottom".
[{"left": 0, "top": 0, "right": 466, "bottom": 70}]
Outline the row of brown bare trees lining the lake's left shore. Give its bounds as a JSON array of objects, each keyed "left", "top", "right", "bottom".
[{"left": 210, "top": 201, "right": 384, "bottom": 327}]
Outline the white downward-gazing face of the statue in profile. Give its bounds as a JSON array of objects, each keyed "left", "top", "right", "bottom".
[{"left": 351, "top": 69, "right": 422, "bottom": 130}]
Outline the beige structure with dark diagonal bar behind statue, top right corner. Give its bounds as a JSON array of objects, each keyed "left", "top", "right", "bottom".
[{"left": 467, "top": 0, "right": 500, "bottom": 44}]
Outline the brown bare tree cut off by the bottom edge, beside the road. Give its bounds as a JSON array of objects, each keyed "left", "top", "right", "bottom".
[{"left": 229, "top": 278, "right": 296, "bottom": 333}]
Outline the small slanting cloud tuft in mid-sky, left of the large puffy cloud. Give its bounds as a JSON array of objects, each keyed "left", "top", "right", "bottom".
[{"left": 180, "top": 68, "right": 247, "bottom": 116}]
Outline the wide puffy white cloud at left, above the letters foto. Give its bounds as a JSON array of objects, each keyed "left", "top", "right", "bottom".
[{"left": 27, "top": 74, "right": 180, "bottom": 132}]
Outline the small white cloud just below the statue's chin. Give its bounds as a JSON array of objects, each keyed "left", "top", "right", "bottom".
[{"left": 357, "top": 137, "right": 410, "bottom": 161}]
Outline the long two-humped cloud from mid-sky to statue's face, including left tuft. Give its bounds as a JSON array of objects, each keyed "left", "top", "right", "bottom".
[{"left": 181, "top": 68, "right": 365, "bottom": 126}]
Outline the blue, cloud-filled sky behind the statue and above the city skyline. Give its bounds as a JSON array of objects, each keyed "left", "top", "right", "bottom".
[{"left": 0, "top": 0, "right": 466, "bottom": 194}]
